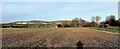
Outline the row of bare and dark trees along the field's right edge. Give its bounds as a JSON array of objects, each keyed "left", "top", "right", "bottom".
[{"left": 59, "top": 15, "right": 120, "bottom": 27}]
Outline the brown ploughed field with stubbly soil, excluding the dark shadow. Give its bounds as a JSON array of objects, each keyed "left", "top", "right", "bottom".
[{"left": 2, "top": 28, "right": 118, "bottom": 47}]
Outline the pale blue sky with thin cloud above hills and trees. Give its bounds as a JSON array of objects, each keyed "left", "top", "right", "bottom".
[{"left": 2, "top": 0, "right": 118, "bottom": 23}]
